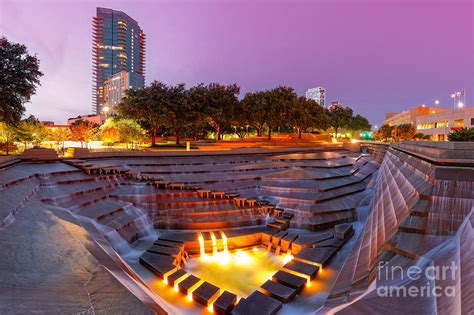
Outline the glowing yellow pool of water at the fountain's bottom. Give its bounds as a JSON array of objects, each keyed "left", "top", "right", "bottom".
[{"left": 184, "top": 248, "right": 292, "bottom": 297}]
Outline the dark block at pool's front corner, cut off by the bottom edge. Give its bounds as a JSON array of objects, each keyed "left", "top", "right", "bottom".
[{"left": 232, "top": 291, "right": 282, "bottom": 315}]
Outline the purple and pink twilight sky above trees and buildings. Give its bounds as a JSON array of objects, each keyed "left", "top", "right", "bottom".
[{"left": 0, "top": 0, "right": 474, "bottom": 124}]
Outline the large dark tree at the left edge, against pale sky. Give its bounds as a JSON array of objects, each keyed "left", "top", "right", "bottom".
[{"left": 0, "top": 37, "right": 43, "bottom": 124}]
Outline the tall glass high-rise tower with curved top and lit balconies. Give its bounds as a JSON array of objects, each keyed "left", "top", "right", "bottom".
[{"left": 92, "top": 8, "right": 145, "bottom": 114}]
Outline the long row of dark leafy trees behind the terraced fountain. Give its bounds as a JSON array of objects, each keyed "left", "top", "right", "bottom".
[{"left": 117, "top": 81, "right": 371, "bottom": 145}]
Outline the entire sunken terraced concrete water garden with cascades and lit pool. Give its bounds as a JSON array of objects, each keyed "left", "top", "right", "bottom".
[{"left": 0, "top": 141, "right": 474, "bottom": 315}]
